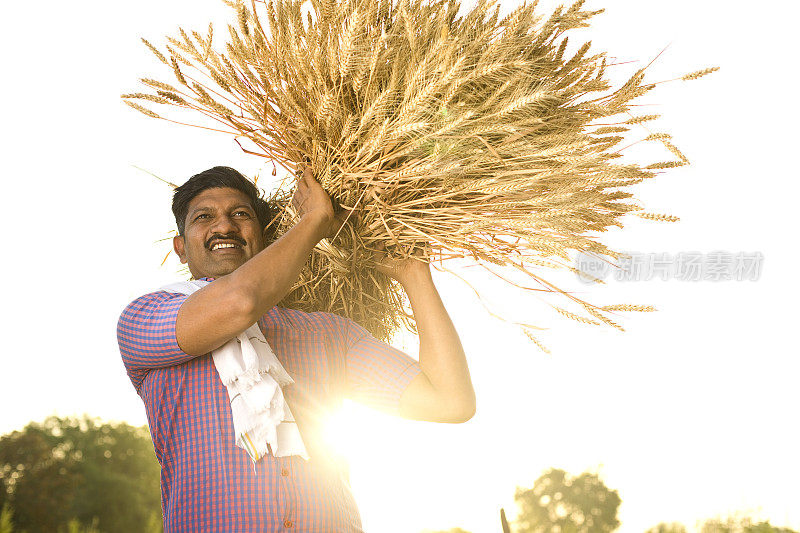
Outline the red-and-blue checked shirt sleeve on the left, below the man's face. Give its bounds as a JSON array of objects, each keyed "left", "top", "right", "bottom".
[{"left": 117, "top": 291, "right": 195, "bottom": 391}]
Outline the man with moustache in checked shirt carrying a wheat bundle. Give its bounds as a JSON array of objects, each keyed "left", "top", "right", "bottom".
[{"left": 117, "top": 167, "right": 475, "bottom": 533}]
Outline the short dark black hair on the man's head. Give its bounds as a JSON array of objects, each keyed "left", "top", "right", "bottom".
[{"left": 172, "top": 167, "right": 275, "bottom": 235}]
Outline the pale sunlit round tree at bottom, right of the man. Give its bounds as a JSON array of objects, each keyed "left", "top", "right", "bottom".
[{"left": 514, "top": 468, "right": 621, "bottom": 533}]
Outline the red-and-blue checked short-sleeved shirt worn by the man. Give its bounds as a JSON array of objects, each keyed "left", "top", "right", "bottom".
[{"left": 117, "top": 280, "right": 420, "bottom": 533}]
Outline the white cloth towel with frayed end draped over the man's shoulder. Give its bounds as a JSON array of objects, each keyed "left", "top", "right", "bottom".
[{"left": 160, "top": 280, "right": 308, "bottom": 462}]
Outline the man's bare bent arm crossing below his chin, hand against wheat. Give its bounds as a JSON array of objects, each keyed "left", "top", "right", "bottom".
[{"left": 175, "top": 168, "right": 338, "bottom": 356}]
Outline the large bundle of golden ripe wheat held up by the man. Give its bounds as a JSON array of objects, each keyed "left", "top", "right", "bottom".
[{"left": 123, "top": 0, "right": 716, "bottom": 346}]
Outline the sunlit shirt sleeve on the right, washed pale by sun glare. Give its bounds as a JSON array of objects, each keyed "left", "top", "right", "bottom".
[{"left": 345, "top": 321, "right": 422, "bottom": 414}]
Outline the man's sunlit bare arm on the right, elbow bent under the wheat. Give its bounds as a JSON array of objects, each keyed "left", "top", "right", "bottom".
[{"left": 379, "top": 259, "right": 475, "bottom": 423}]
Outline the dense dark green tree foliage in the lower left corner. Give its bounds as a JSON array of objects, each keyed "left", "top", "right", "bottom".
[{"left": 0, "top": 417, "right": 161, "bottom": 533}]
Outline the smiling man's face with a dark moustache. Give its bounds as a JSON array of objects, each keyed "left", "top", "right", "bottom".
[{"left": 173, "top": 187, "right": 264, "bottom": 279}]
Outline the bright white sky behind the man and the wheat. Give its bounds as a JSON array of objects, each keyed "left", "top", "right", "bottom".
[{"left": 0, "top": 0, "right": 800, "bottom": 533}]
